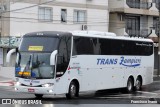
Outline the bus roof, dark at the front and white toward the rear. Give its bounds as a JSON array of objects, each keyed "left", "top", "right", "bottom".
[{"left": 23, "top": 31, "right": 153, "bottom": 42}]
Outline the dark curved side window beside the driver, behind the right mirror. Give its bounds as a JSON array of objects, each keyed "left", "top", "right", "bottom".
[{"left": 56, "top": 37, "right": 71, "bottom": 77}]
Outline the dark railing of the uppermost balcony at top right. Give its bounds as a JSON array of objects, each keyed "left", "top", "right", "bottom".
[{"left": 126, "top": 0, "right": 152, "bottom": 9}]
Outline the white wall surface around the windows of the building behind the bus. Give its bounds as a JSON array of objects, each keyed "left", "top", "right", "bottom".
[{"left": 10, "top": 0, "right": 109, "bottom": 36}]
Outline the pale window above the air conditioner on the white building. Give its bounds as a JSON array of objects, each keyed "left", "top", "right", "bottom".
[{"left": 74, "top": 10, "right": 87, "bottom": 23}]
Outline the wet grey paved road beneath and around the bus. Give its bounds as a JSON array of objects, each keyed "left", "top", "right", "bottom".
[{"left": 0, "top": 78, "right": 160, "bottom": 107}]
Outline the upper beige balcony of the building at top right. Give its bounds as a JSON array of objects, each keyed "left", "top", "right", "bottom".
[{"left": 108, "top": 0, "right": 159, "bottom": 16}]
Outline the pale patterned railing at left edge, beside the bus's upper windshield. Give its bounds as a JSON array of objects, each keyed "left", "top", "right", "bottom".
[{"left": 0, "top": 36, "right": 21, "bottom": 48}]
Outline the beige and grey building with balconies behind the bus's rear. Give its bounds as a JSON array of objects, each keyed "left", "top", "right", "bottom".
[{"left": 109, "top": 0, "right": 160, "bottom": 72}]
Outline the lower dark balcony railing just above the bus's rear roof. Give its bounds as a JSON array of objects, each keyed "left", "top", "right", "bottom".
[{"left": 126, "top": 29, "right": 152, "bottom": 38}]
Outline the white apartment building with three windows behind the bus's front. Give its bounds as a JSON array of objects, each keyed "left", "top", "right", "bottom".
[{"left": 0, "top": 0, "right": 109, "bottom": 66}]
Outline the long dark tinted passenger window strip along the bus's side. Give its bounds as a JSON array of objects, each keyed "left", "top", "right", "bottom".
[{"left": 73, "top": 37, "right": 153, "bottom": 56}]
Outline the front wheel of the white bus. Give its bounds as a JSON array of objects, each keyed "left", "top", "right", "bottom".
[{"left": 66, "top": 81, "right": 78, "bottom": 99}]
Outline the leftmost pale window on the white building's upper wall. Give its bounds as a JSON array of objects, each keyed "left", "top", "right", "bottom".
[{"left": 38, "top": 7, "right": 53, "bottom": 21}]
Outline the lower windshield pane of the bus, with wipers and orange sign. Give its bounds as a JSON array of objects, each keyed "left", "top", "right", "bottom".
[{"left": 15, "top": 52, "right": 54, "bottom": 79}]
